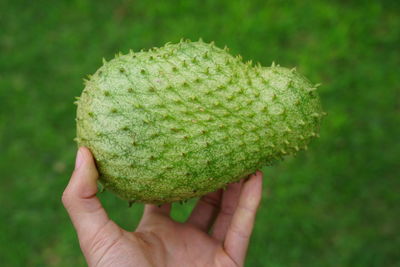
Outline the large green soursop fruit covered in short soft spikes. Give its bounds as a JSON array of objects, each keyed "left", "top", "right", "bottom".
[{"left": 77, "top": 41, "right": 323, "bottom": 204}]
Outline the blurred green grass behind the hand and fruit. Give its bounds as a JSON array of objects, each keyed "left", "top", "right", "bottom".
[{"left": 0, "top": 0, "right": 400, "bottom": 266}]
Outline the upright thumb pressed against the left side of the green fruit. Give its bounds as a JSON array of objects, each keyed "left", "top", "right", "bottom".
[{"left": 62, "top": 147, "right": 110, "bottom": 246}]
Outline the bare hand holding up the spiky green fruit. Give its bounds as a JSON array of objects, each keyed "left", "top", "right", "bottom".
[{"left": 62, "top": 147, "right": 262, "bottom": 267}]
